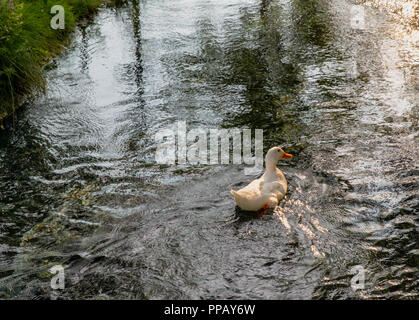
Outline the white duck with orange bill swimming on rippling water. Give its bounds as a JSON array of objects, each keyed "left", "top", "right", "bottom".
[{"left": 230, "top": 147, "right": 292, "bottom": 215}]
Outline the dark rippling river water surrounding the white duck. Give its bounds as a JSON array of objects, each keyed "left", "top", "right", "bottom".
[{"left": 0, "top": 0, "right": 419, "bottom": 299}]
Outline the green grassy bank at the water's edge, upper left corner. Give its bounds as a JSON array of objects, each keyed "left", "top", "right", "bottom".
[{"left": 0, "top": 0, "right": 108, "bottom": 126}]
